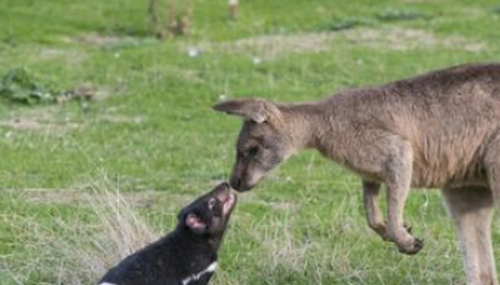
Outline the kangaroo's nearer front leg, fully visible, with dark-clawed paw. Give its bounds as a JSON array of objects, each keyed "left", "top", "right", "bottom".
[{"left": 385, "top": 141, "right": 424, "bottom": 254}]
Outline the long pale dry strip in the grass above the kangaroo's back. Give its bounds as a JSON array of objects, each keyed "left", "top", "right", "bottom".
[{"left": 194, "top": 27, "right": 488, "bottom": 60}]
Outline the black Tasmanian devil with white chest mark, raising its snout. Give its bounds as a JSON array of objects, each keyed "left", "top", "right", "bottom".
[{"left": 98, "top": 183, "right": 237, "bottom": 285}]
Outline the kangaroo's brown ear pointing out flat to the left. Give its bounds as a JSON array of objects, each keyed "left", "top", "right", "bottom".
[{"left": 213, "top": 98, "right": 281, "bottom": 123}]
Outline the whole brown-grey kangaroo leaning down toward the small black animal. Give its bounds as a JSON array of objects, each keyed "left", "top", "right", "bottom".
[{"left": 213, "top": 64, "right": 500, "bottom": 285}]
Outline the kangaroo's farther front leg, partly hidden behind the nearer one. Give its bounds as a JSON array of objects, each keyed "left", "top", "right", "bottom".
[{"left": 363, "top": 180, "right": 388, "bottom": 240}]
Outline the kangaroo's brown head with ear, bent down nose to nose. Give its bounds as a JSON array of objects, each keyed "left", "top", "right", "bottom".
[{"left": 213, "top": 99, "right": 293, "bottom": 192}]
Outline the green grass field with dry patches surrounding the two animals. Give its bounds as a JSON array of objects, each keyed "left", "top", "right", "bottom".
[{"left": 0, "top": 0, "right": 500, "bottom": 285}]
